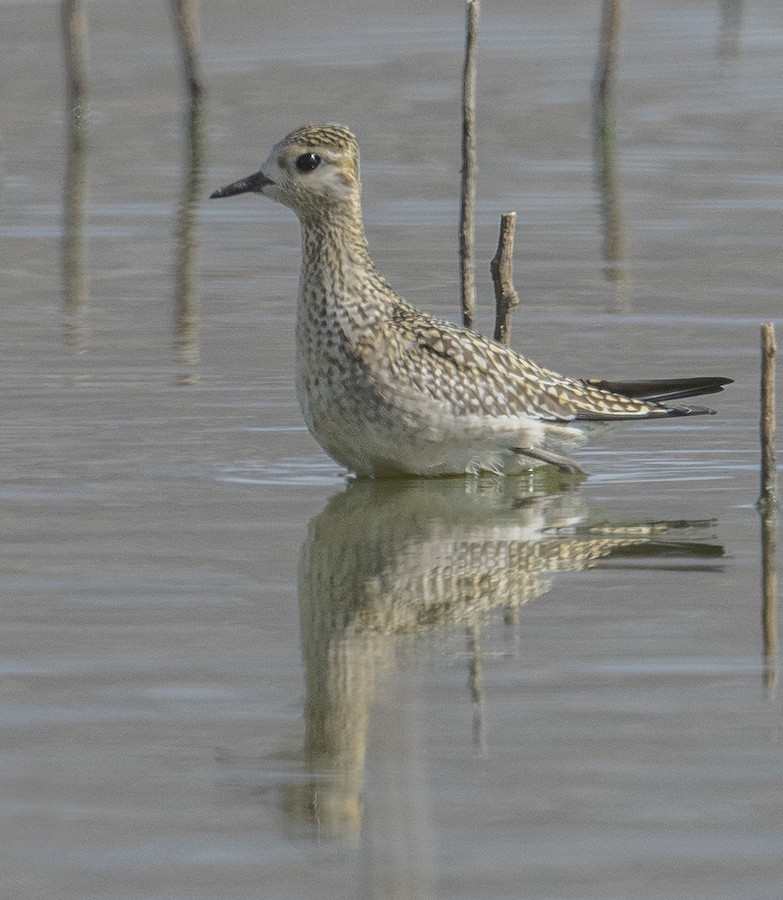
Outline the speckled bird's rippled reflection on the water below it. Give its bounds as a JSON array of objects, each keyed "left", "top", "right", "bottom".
[{"left": 284, "top": 478, "right": 722, "bottom": 838}]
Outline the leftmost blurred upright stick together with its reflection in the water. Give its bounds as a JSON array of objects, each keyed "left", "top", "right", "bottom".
[{"left": 60, "top": 0, "right": 87, "bottom": 324}]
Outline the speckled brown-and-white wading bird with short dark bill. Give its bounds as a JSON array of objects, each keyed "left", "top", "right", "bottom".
[{"left": 212, "top": 125, "right": 729, "bottom": 475}]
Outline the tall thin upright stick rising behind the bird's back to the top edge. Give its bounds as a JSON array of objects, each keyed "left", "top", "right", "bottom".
[{"left": 459, "top": 0, "right": 480, "bottom": 328}]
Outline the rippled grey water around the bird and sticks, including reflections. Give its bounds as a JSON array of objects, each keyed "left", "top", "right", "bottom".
[{"left": 0, "top": 0, "right": 783, "bottom": 900}]
